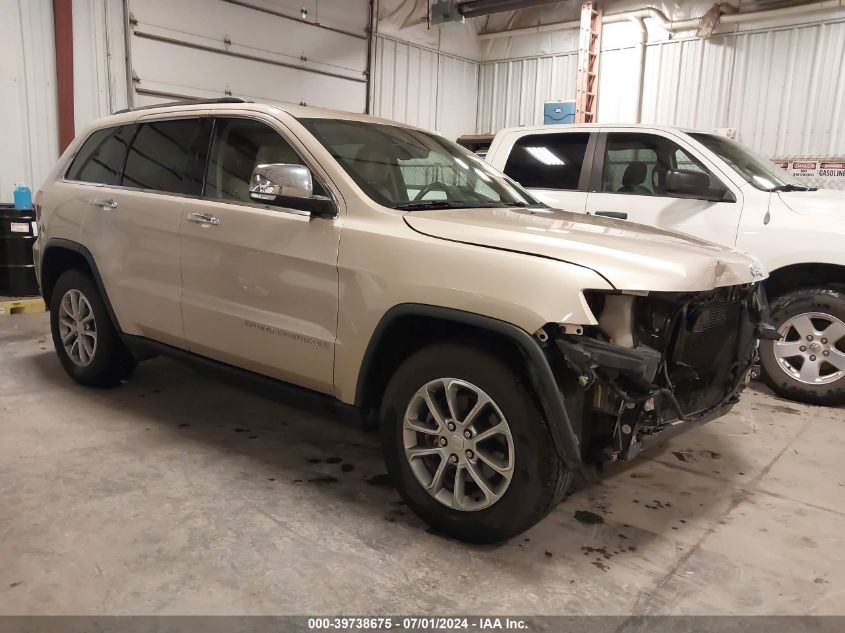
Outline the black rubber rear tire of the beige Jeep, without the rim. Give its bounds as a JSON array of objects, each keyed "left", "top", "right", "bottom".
[{"left": 50, "top": 268, "right": 137, "bottom": 387}]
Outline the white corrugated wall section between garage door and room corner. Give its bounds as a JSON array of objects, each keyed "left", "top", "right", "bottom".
[{"left": 371, "top": 35, "right": 479, "bottom": 139}]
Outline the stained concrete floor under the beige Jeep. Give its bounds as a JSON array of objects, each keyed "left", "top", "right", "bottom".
[{"left": 0, "top": 314, "right": 845, "bottom": 615}]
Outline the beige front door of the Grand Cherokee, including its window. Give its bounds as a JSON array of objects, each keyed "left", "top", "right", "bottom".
[{"left": 181, "top": 117, "right": 342, "bottom": 393}]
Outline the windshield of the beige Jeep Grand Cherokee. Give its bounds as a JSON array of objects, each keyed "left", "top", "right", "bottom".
[{"left": 300, "top": 118, "right": 545, "bottom": 210}]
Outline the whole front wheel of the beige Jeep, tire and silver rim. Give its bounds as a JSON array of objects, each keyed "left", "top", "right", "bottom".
[{"left": 381, "top": 344, "right": 571, "bottom": 543}]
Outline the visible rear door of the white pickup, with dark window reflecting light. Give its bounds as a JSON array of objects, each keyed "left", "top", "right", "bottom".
[{"left": 503, "top": 130, "right": 592, "bottom": 213}]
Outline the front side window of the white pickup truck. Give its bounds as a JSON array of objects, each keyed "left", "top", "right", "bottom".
[{"left": 601, "top": 133, "right": 720, "bottom": 196}]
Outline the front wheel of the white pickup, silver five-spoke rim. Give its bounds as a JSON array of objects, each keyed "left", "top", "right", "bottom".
[{"left": 760, "top": 288, "right": 845, "bottom": 405}]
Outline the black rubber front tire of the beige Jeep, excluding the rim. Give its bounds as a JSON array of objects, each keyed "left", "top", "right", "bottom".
[{"left": 381, "top": 343, "right": 571, "bottom": 543}]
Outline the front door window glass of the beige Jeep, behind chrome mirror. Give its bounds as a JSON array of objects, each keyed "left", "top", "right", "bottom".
[{"left": 205, "top": 119, "right": 326, "bottom": 202}]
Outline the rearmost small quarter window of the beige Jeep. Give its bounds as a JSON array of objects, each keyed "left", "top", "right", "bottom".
[{"left": 67, "top": 125, "right": 137, "bottom": 185}]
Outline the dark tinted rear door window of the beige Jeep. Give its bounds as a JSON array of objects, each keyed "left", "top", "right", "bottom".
[{"left": 121, "top": 119, "right": 210, "bottom": 195}]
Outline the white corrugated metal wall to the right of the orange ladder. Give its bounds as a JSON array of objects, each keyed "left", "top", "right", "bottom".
[{"left": 599, "top": 22, "right": 845, "bottom": 156}]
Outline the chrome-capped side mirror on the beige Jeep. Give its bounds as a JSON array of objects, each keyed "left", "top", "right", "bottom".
[{"left": 249, "top": 163, "right": 337, "bottom": 217}]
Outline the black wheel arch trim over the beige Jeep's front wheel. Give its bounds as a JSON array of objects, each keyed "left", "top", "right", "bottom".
[{"left": 355, "top": 303, "right": 582, "bottom": 471}]
